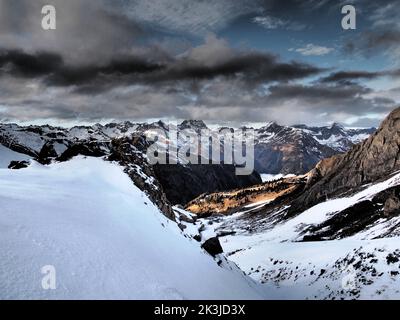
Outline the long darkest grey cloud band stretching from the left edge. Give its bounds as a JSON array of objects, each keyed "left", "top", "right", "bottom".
[{"left": 0, "top": 50, "right": 322, "bottom": 93}]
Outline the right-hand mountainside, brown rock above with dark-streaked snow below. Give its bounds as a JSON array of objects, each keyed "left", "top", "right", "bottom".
[{"left": 177, "top": 108, "right": 400, "bottom": 299}]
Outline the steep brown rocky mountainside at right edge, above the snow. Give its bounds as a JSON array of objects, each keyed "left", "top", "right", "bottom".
[{"left": 291, "top": 108, "right": 400, "bottom": 212}]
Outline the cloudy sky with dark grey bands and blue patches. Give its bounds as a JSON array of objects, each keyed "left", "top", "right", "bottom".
[{"left": 0, "top": 0, "right": 400, "bottom": 126}]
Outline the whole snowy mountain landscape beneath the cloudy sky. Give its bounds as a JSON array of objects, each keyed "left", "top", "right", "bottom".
[{"left": 0, "top": 108, "right": 400, "bottom": 299}]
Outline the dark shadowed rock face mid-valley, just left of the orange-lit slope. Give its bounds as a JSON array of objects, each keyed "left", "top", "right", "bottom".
[{"left": 153, "top": 164, "right": 261, "bottom": 205}]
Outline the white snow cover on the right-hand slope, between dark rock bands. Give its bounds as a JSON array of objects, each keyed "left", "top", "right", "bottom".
[{"left": 193, "top": 173, "right": 400, "bottom": 299}]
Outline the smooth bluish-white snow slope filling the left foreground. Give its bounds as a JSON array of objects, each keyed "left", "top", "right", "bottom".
[{"left": 0, "top": 158, "right": 265, "bottom": 299}]
